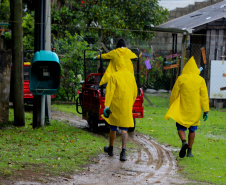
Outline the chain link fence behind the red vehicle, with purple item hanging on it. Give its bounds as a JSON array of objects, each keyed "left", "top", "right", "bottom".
[{"left": 57, "top": 30, "right": 182, "bottom": 91}]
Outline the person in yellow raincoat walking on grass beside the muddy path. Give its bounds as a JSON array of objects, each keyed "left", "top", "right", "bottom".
[{"left": 165, "top": 57, "right": 209, "bottom": 158}]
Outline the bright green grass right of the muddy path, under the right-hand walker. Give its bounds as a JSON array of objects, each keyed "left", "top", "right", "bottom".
[{"left": 136, "top": 95, "right": 226, "bottom": 184}]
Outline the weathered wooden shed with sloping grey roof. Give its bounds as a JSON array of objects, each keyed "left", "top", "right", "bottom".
[{"left": 159, "top": 0, "right": 226, "bottom": 104}]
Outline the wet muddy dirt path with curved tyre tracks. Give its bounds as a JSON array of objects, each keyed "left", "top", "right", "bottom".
[{"left": 46, "top": 111, "right": 200, "bottom": 185}]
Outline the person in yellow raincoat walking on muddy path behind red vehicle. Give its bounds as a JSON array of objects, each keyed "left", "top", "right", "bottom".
[{"left": 102, "top": 54, "right": 138, "bottom": 161}]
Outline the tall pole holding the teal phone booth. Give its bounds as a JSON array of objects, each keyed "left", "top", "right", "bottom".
[{"left": 33, "top": 0, "right": 51, "bottom": 128}]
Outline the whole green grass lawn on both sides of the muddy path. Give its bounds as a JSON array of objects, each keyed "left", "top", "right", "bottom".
[{"left": 0, "top": 95, "right": 226, "bottom": 184}]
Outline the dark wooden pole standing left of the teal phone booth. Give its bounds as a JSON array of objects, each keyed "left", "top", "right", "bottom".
[{"left": 10, "top": 0, "right": 25, "bottom": 126}]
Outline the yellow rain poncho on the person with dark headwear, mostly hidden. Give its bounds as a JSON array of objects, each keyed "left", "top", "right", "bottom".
[{"left": 97, "top": 47, "right": 137, "bottom": 86}]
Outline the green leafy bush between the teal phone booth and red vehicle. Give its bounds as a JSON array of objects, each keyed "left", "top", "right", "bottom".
[{"left": 55, "top": 31, "right": 88, "bottom": 101}]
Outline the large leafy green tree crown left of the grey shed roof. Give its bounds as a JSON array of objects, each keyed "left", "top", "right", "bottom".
[{"left": 52, "top": 0, "right": 168, "bottom": 39}]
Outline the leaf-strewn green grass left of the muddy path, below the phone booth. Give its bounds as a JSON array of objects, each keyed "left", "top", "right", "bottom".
[{"left": 0, "top": 109, "right": 108, "bottom": 176}]
